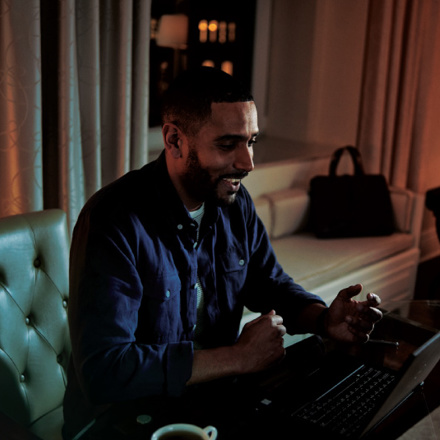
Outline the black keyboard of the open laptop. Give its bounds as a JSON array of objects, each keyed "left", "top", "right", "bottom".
[{"left": 292, "top": 367, "right": 396, "bottom": 437}]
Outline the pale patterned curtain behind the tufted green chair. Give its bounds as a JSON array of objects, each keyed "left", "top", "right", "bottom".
[{"left": 0, "top": 0, "right": 151, "bottom": 229}]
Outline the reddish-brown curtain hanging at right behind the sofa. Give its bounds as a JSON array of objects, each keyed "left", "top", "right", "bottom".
[{"left": 358, "top": 0, "right": 440, "bottom": 192}]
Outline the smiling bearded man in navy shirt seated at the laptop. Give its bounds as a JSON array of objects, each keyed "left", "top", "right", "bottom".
[{"left": 64, "top": 68, "right": 381, "bottom": 438}]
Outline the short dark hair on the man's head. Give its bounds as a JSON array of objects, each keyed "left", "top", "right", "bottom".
[{"left": 161, "top": 66, "right": 254, "bottom": 135}]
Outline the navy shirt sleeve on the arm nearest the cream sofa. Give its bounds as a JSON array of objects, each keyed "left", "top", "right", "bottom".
[{"left": 237, "top": 186, "right": 326, "bottom": 333}]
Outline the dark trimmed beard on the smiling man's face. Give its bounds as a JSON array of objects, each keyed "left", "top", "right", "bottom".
[{"left": 183, "top": 147, "right": 248, "bottom": 206}]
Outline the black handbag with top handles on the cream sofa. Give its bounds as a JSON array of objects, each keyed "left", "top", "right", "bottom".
[{"left": 310, "top": 146, "right": 394, "bottom": 238}]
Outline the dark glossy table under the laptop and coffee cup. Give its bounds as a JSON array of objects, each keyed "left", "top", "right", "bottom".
[{"left": 0, "top": 300, "right": 440, "bottom": 440}]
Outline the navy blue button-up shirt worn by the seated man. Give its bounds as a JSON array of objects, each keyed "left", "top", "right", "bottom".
[{"left": 65, "top": 154, "right": 320, "bottom": 436}]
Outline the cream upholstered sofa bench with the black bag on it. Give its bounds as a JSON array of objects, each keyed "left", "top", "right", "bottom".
[{"left": 243, "top": 184, "right": 424, "bottom": 344}]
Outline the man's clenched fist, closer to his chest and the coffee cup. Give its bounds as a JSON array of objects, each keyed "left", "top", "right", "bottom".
[{"left": 234, "top": 310, "right": 286, "bottom": 373}]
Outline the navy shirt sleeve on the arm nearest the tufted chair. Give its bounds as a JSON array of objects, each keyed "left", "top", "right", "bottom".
[{"left": 69, "top": 205, "right": 193, "bottom": 404}]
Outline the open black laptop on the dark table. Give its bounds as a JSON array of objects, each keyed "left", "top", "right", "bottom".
[{"left": 251, "top": 315, "right": 440, "bottom": 440}]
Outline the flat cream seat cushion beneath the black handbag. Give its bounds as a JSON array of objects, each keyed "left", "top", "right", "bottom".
[{"left": 272, "top": 232, "right": 414, "bottom": 290}]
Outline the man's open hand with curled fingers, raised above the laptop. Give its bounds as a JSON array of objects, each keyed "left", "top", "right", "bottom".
[{"left": 324, "top": 284, "right": 382, "bottom": 342}]
